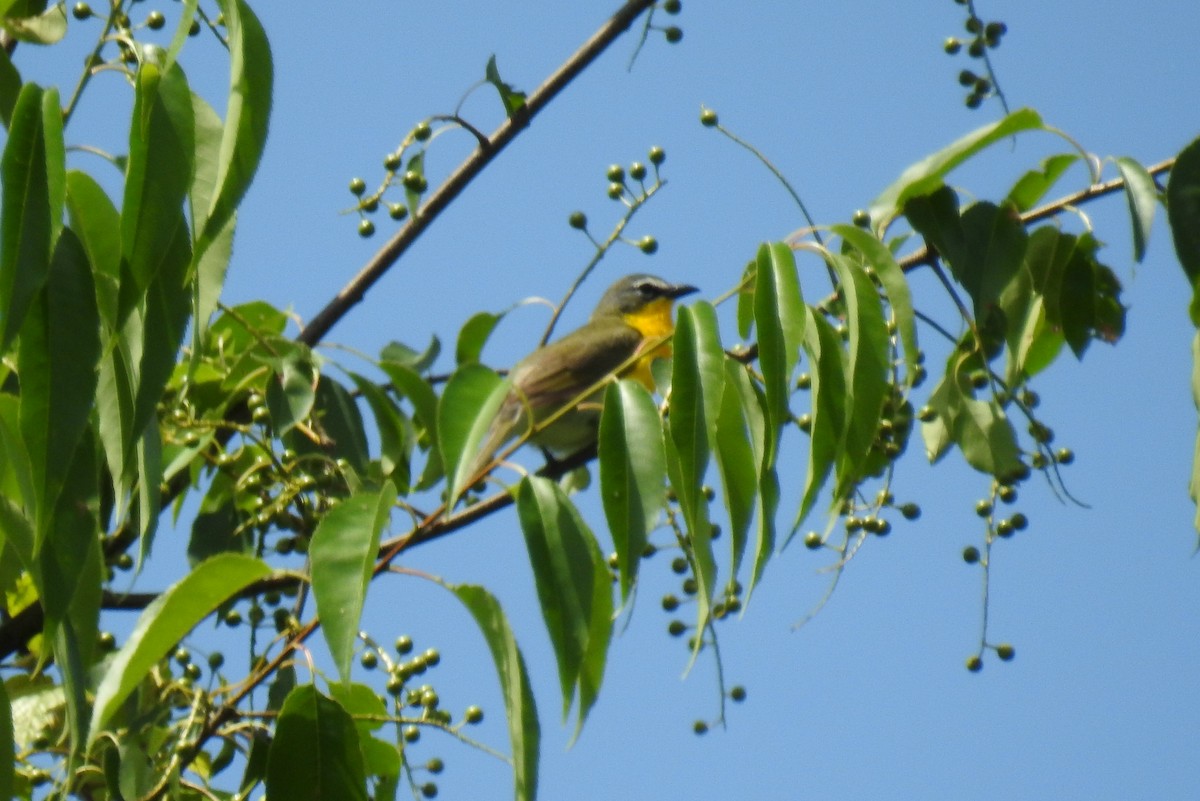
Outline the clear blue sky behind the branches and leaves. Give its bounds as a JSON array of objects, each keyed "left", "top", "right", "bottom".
[{"left": 18, "top": 0, "right": 1200, "bottom": 801}]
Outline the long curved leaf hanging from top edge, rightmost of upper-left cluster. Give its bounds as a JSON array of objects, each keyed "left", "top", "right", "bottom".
[{"left": 196, "top": 0, "right": 275, "bottom": 258}]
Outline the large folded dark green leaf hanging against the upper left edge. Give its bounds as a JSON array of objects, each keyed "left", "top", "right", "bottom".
[{"left": 0, "top": 83, "right": 66, "bottom": 353}]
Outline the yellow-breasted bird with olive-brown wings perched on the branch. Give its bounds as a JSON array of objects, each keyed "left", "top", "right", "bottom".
[{"left": 467, "top": 273, "right": 698, "bottom": 476}]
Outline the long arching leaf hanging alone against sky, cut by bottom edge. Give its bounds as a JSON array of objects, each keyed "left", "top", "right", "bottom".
[{"left": 449, "top": 584, "right": 541, "bottom": 801}]
